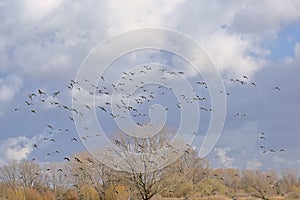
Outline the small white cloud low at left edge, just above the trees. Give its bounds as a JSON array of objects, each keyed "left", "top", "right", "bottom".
[{"left": 0, "top": 136, "right": 42, "bottom": 165}]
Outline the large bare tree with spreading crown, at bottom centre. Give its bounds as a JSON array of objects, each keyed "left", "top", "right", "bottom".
[{"left": 108, "top": 129, "right": 180, "bottom": 200}]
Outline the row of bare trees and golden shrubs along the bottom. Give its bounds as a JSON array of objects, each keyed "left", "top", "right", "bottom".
[{"left": 0, "top": 123, "right": 300, "bottom": 200}]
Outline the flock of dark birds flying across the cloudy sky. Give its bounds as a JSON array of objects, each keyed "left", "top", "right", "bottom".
[{"left": 9, "top": 66, "right": 285, "bottom": 169}]
